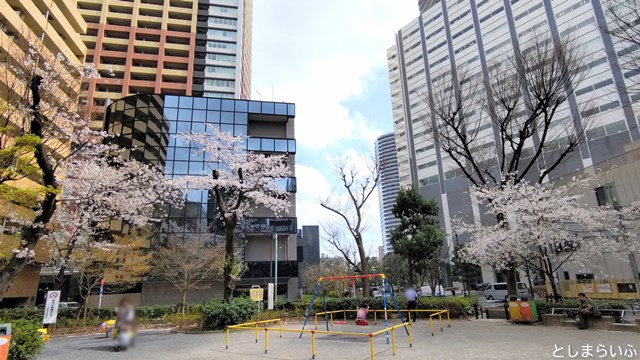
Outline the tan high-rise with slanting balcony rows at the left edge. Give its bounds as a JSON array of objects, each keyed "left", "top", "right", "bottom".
[{"left": 0, "top": 0, "right": 87, "bottom": 307}]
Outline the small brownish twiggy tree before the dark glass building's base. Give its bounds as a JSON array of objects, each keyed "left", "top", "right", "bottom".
[{"left": 152, "top": 239, "right": 225, "bottom": 313}]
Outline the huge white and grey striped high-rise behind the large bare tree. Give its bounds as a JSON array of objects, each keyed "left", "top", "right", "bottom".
[{"left": 387, "top": 0, "right": 640, "bottom": 279}]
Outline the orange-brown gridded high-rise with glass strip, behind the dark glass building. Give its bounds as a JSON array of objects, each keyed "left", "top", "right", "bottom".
[{"left": 78, "top": 0, "right": 253, "bottom": 128}]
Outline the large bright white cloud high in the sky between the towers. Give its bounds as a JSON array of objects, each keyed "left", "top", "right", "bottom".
[{"left": 252, "top": 0, "right": 418, "bottom": 149}]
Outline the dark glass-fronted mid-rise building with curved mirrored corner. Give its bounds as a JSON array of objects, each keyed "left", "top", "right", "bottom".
[{"left": 106, "top": 94, "right": 298, "bottom": 304}]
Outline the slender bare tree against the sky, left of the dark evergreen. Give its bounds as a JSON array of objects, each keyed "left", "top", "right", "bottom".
[{"left": 320, "top": 157, "right": 380, "bottom": 296}]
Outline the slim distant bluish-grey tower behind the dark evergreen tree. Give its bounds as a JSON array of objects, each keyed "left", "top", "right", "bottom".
[{"left": 376, "top": 133, "right": 400, "bottom": 253}]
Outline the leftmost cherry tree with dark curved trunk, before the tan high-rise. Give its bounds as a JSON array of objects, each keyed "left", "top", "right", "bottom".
[{"left": 0, "top": 42, "right": 102, "bottom": 297}]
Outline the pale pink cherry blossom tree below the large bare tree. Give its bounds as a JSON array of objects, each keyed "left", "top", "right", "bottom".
[{"left": 457, "top": 179, "right": 627, "bottom": 297}]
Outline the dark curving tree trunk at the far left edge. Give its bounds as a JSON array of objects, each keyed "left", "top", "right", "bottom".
[{"left": 0, "top": 76, "right": 58, "bottom": 299}]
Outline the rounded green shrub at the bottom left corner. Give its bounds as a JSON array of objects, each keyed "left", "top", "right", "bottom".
[{"left": 8, "top": 320, "right": 44, "bottom": 360}]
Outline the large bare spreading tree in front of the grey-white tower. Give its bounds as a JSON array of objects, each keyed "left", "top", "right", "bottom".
[{"left": 426, "top": 34, "right": 589, "bottom": 294}]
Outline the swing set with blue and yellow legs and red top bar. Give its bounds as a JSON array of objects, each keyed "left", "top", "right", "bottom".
[{"left": 300, "top": 274, "right": 409, "bottom": 343}]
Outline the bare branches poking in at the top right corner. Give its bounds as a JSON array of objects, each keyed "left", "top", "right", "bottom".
[{"left": 601, "top": 0, "right": 640, "bottom": 91}]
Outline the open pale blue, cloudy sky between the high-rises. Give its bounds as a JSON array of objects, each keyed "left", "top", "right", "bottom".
[{"left": 252, "top": 0, "right": 418, "bottom": 255}]
